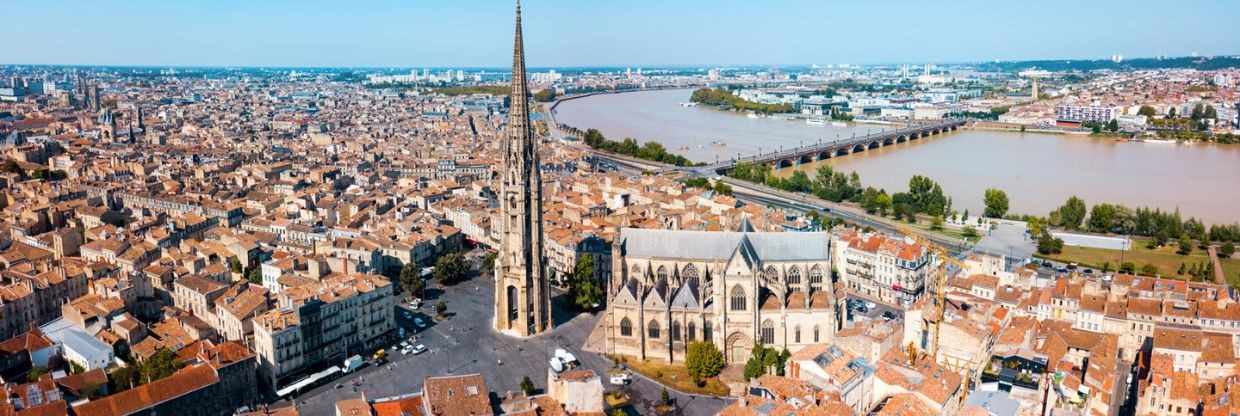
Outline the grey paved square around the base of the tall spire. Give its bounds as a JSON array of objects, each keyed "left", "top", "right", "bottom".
[{"left": 283, "top": 257, "right": 728, "bottom": 415}]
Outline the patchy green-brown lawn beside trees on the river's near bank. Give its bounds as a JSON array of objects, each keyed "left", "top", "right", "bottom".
[{"left": 1038, "top": 238, "right": 1240, "bottom": 287}]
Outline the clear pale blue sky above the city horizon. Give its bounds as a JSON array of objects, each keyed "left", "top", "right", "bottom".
[{"left": 0, "top": 0, "right": 1240, "bottom": 67}]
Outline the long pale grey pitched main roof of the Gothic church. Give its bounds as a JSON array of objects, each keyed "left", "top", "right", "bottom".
[{"left": 620, "top": 228, "right": 831, "bottom": 262}]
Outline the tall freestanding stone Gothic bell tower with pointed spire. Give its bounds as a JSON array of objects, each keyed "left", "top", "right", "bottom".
[{"left": 495, "top": 0, "right": 552, "bottom": 337}]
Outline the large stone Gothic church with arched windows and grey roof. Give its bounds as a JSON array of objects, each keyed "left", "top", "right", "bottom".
[{"left": 604, "top": 228, "right": 841, "bottom": 364}]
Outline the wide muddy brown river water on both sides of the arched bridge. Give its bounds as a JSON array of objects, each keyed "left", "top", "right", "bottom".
[{"left": 557, "top": 89, "right": 1240, "bottom": 224}]
